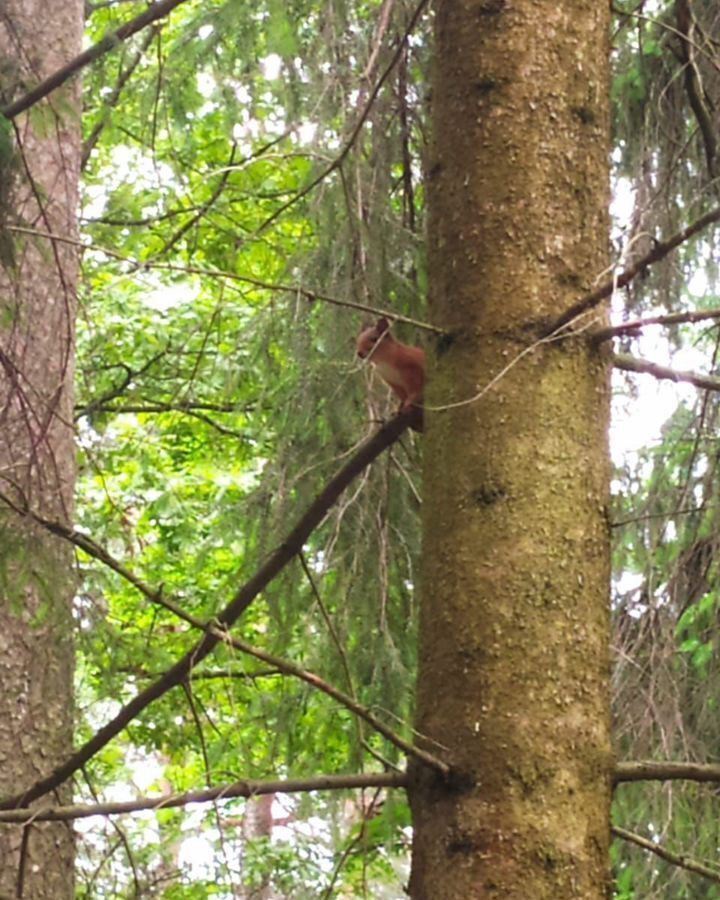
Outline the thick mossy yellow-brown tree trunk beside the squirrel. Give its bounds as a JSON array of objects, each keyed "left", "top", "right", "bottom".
[{"left": 411, "top": 0, "right": 611, "bottom": 900}]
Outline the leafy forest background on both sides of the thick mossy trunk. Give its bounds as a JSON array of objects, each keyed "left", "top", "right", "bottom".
[{"left": 0, "top": 0, "right": 720, "bottom": 900}]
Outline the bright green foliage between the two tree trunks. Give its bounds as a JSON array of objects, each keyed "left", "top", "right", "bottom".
[{"left": 71, "top": 0, "right": 426, "bottom": 898}]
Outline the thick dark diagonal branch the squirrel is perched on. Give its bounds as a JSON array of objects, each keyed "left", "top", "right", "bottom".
[{"left": 0, "top": 409, "right": 416, "bottom": 809}]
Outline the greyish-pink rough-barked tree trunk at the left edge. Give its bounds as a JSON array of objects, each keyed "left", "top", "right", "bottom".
[{"left": 0, "top": 0, "right": 83, "bottom": 900}]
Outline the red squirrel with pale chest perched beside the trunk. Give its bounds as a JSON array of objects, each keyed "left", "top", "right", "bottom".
[{"left": 356, "top": 316, "right": 425, "bottom": 431}]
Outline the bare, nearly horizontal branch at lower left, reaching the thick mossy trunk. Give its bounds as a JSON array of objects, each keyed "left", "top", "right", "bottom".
[{"left": 0, "top": 772, "right": 408, "bottom": 824}]
